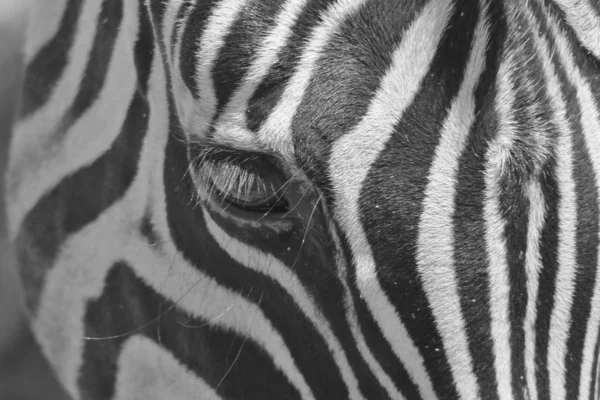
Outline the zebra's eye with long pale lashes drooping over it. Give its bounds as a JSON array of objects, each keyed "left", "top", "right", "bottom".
[{"left": 206, "top": 162, "right": 288, "bottom": 213}]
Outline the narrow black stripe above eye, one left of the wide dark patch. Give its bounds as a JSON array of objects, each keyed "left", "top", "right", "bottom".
[{"left": 247, "top": 0, "right": 335, "bottom": 131}]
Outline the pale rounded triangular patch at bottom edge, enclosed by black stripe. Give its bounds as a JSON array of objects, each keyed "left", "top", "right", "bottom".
[{"left": 114, "top": 335, "right": 221, "bottom": 400}]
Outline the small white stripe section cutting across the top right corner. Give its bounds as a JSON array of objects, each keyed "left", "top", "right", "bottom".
[{"left": 555, "top": 0, "right": 600, "bottom": 58}]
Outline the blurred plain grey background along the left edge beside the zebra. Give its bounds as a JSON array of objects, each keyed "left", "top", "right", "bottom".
[{"left": 0, "top": 0, "right": 67, "bottom": 400}]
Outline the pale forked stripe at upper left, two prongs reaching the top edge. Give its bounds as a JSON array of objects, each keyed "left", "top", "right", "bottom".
[{"left": 6, "top": 1, "right": 138, "bottom": 237}]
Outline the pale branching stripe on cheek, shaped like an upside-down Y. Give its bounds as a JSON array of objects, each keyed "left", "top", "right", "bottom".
[{"left": 33, "top": 46, "right": 314, "bottom": 399}]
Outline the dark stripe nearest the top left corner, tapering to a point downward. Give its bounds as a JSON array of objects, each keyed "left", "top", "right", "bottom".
[{"left": 20, "top": 0, "right": 84, "bottom": 118}]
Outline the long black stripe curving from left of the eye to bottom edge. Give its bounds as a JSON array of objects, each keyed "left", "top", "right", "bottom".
[{"left": 164, "top": 126, "right": 348, "bottom": 399}]
